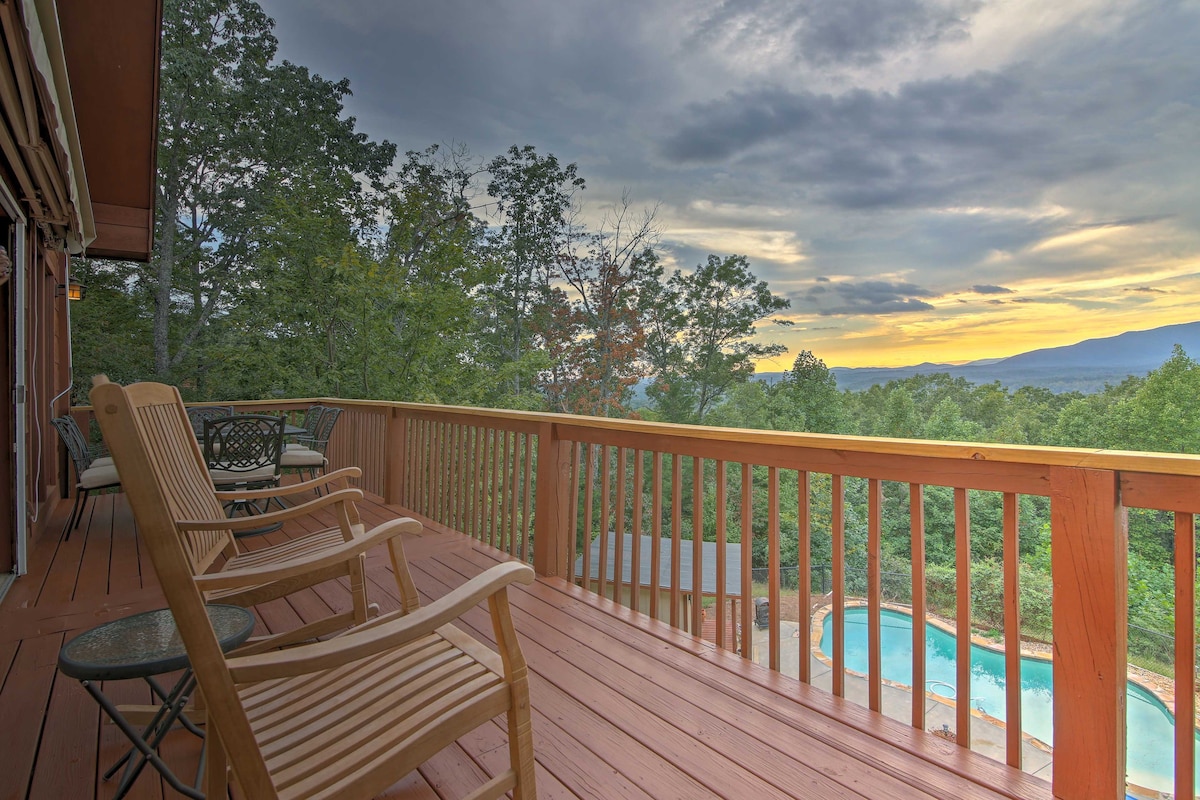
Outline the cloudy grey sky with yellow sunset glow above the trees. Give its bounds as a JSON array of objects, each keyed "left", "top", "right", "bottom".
[{"left": 262, "top": 0, "right": 1200, "bottom": 371}]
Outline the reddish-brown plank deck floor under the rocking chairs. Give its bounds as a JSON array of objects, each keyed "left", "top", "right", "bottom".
[{"left": 0, "top": 495, "right": 1050, "bottom": 800}]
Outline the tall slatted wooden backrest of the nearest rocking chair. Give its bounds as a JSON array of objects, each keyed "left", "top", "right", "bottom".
[{"left": 91, "top": 375, "right": 271, "bottom": 796}]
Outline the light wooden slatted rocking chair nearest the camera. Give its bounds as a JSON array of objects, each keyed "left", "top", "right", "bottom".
[{"left": 91, "top": 379, "right": 535, "bottom": 800}]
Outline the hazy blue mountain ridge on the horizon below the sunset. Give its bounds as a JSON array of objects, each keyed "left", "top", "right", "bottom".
[{"left": 825, "top": 321, "right": 1200, "bottom": 393}]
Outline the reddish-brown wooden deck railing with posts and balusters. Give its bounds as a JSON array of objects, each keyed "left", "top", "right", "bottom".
[{"left": 72, "top": 398, "right": 1200, "bottom": 799}]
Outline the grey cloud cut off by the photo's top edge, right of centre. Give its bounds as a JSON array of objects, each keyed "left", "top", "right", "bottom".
[{"left": 695, "top": 0, "right": 983, "bottom": 66}]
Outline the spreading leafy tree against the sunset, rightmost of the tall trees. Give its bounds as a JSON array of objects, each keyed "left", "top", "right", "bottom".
[{"left": 647, "top": 255, "right": 791, "bottom": 422}]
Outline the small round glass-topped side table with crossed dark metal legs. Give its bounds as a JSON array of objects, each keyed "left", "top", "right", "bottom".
[{"left": 59, "top": 604, "right": 254, "bottom": 800}]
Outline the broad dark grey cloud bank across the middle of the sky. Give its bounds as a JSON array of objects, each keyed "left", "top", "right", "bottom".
[{"left": 660, "top": 72, "right": 1070, "bottom": 210}]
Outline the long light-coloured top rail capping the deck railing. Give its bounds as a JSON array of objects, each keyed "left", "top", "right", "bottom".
[{"left": 72, "top": 397, "right": 1200, "bottom": 476}]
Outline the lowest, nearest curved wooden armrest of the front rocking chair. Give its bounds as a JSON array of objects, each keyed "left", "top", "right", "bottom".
[{"left": 227, "top": 561, "right": 534, "bottom": 684}]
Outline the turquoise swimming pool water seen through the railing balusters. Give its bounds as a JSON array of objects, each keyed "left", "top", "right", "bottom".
[{"left": 821, "top": 608, "right": 1200, "bottom": 792}]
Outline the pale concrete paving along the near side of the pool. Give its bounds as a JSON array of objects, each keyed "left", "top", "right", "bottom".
[{"left": 752, "top": 621, "right": 1052, "bottom": 780}]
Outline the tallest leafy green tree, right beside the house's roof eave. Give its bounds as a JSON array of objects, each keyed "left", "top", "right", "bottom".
[{"left": 150, "top": 0, "right": 395, "bottom": 383}]
